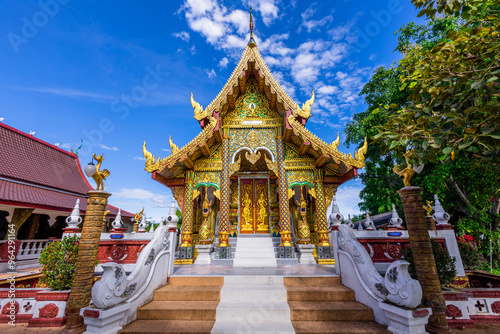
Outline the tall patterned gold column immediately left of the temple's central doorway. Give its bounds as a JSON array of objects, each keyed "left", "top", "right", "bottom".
[{"left": 216, "top": 129, "right": 231, "bottom": 259}]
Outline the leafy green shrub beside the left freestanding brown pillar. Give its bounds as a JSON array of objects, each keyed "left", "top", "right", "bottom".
[{"left": 38, "top": 235, "right": 80, "bottom": 290}]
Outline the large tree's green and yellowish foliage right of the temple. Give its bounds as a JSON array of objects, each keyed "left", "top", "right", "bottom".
[{"left": 346, "top": 0, "right": 500, "bottom": 268}]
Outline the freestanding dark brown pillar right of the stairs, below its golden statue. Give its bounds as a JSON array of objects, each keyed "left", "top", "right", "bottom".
[{"left": 398, "top": 187, "right": 451, "bottom": 333}]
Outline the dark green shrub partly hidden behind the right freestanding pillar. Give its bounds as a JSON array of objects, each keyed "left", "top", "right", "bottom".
[{"left": 403, "top": 239, "right": 457, "bottom": 285}]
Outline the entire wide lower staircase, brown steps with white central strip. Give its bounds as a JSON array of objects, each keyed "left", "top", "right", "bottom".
[{"left": 119, "top": 276, "right": 390, "bottom": 334}]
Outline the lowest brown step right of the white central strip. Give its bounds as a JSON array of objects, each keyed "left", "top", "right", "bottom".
[{"left": 293, "top": 321, "right": 391, "bottom": 334}]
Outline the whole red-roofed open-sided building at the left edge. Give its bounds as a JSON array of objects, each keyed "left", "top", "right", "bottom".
[{"left": 0, "top": 123, "right": 133, "bottom": 240}]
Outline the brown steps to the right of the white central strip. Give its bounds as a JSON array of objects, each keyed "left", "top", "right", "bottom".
[{"left": 284, "top": 277, "right": 390, "bottom": 334}]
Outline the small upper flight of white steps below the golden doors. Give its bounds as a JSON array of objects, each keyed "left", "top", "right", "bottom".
[{"left": 233, "top": 236, "right": 278, "bottom": 267}]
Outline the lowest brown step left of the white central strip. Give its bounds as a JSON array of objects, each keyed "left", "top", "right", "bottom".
[{"left": 118, "top": 320, "right": 214, "bottom": 334}]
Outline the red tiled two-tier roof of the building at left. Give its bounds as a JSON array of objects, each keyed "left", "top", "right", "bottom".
[{"left": 0, "top": 123, "right": 133, "bottom": 218}]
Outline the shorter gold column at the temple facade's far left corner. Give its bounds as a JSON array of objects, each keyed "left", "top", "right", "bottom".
[{"left": 178, "top": 170, "right": 194, "bottom": 263}]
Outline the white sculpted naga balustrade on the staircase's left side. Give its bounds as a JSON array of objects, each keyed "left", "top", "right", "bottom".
[{"left": 81, "top": 202, "right": 179, "bottom": 333}]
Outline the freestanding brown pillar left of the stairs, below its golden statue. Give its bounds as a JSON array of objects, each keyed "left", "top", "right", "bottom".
[{"left": 63, "top": 190, "right": 111, "bottom": 333}]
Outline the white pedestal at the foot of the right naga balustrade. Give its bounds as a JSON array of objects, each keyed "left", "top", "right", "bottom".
[{"left": 379, "top": 302, "right": 432, "bottom": 334}]
